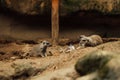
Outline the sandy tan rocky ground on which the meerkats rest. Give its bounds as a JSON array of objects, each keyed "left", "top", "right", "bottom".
[{"left": 0, "top": 41, "right": 120, "bottom": 80}]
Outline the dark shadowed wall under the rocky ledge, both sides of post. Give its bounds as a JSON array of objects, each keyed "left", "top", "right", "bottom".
[{"left": 0, "top": 11, "right": 120, "bottom": 40}]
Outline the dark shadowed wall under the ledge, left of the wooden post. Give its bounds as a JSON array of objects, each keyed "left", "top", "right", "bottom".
[{"left": 0, "top": 13, "right": 51, "bottom": 40}]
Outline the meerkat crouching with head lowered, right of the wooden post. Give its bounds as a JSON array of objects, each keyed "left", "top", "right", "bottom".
[{"left": 79, "top": 35, "right": 103, "bottom": 47}]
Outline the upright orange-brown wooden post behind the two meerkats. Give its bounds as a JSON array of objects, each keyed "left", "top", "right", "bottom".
[{"left": 51, "top": 0, "right": 59, "bottom": 45}]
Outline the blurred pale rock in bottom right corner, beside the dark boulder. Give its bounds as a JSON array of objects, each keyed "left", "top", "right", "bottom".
[{"left": 99, "top": 55, "right": 120, "bottom": 80}]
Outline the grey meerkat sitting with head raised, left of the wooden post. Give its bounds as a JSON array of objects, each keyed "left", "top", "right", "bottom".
[{"left": 31, "top": 40, "right": 50, "bottom": 57}]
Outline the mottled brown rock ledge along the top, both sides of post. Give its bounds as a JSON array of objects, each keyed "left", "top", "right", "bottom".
[{"left": 0, "top": 0, "right": 120, "bottom": 15}]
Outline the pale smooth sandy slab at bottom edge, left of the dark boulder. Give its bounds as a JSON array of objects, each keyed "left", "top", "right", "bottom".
[{"left": 30, "top": 66, "right": 78, "bottom": 80}]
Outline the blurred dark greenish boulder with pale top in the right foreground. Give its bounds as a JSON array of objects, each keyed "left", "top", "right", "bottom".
[{"left": 75, "top": 50, "right": 114, "bottom": 75}]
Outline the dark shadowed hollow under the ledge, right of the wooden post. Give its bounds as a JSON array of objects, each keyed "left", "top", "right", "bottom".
[{"left": 60, "top": 11, "right": 120, "bottom": 38}]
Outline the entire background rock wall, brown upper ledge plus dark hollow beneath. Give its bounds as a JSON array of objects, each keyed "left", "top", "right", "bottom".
[{"left": 0, "top": 0, "right": 120, "bottom": 39}]
